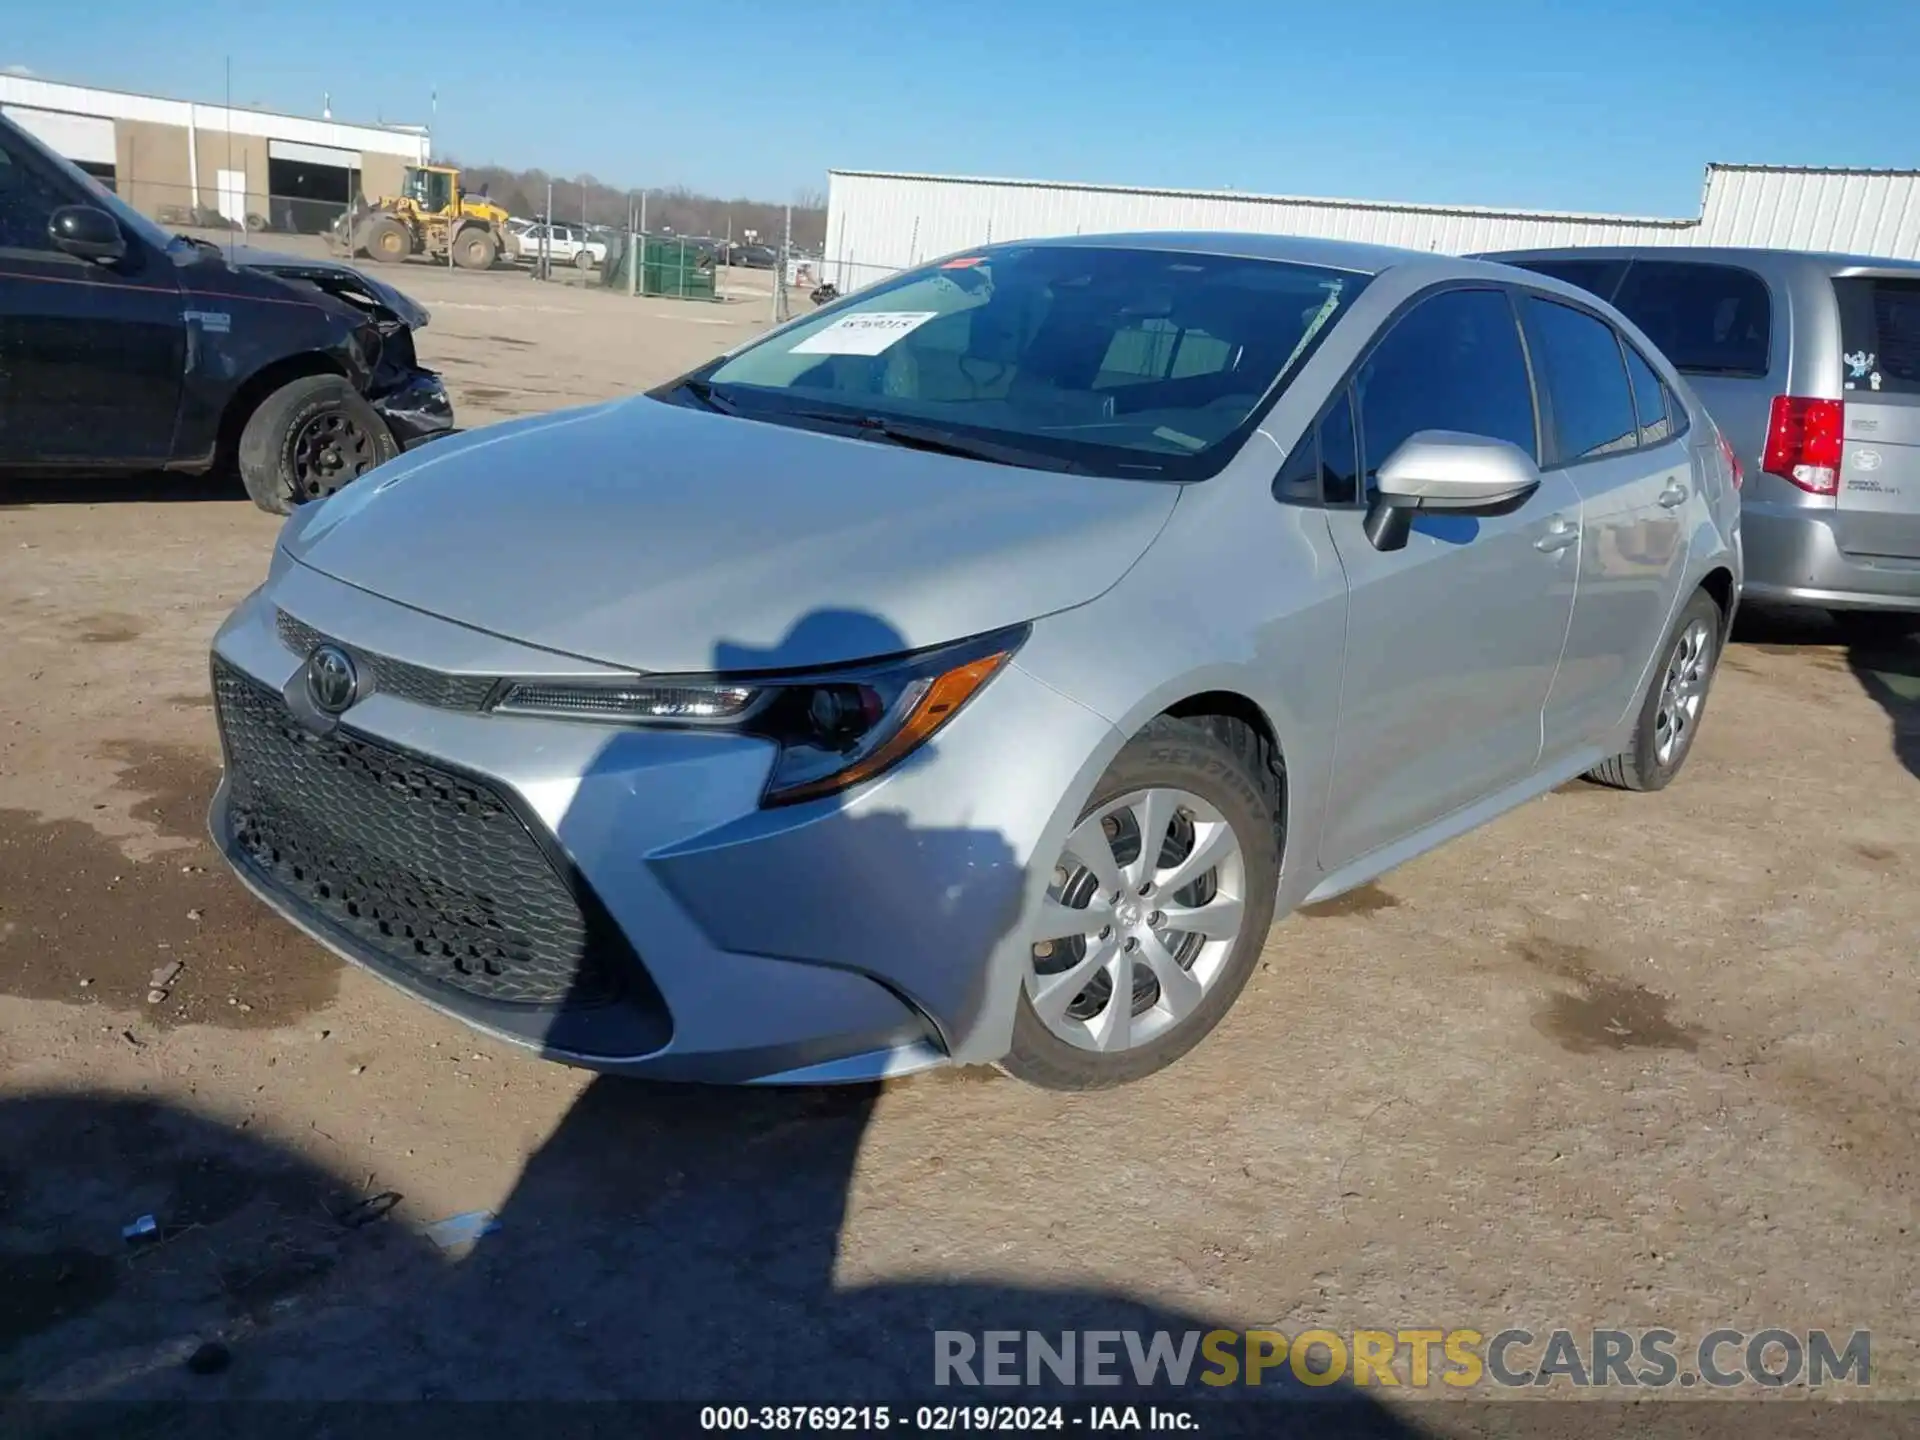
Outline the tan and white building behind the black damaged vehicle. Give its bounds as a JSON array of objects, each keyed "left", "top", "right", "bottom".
[{"left": 0, "top": 75, "right": 428, "bottom": 228}]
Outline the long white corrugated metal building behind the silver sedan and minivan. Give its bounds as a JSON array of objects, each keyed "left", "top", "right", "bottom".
[{"left": 826, "top": 165, "right": 1920, "bottom": 290}]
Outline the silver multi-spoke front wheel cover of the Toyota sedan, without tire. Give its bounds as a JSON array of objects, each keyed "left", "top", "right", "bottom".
[{"left": 1027, "top": 787, "right": 1246, "bottom": 1052}]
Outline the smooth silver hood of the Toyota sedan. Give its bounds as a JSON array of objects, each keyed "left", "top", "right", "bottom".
[{"left": 282, "top": 397, "right": 1179, "bottom": 672}]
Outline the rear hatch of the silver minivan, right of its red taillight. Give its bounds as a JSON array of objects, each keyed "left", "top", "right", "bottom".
[{"left": 1834, "top": 275, "right": 1920, "bottom": 559}]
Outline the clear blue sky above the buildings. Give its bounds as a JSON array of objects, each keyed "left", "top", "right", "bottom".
[{"left": 0, "top": 0, "right": 1920, "bottom": 215}]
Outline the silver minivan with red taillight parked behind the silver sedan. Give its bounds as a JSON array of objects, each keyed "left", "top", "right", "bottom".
[{"left": 1486, "top": 246, "right": 1920, "bottom": 636}]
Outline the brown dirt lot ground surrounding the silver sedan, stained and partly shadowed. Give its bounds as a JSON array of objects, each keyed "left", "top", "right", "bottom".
[{"left": 0, "top": 257, "right": 1920, "bottom": 1428}]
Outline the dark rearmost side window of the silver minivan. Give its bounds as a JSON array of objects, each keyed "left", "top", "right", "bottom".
[{"left": 1613, "top": 259, "right": 1774, "bottom": 376}]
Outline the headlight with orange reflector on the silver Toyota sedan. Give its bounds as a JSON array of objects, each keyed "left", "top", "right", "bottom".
[{"left": 492, "top": 630, "right": 1025, "bottom": 804}]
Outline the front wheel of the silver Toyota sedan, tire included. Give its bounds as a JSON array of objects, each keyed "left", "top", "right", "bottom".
[{"left": 1000, "top": 718, "right": 1281, "bottom": 1091}]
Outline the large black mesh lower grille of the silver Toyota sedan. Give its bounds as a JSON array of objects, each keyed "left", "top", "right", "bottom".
[{"left": 213, "top": 662, "right": 622, "bottom": 1008}]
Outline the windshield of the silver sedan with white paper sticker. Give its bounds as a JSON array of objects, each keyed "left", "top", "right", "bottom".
[{"left": 691, "top": 244, "right": 1369, "bottom": 480}]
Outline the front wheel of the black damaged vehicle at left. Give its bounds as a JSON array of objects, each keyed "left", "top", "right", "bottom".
[{"left": 236, "top": 374, "right": 399, "bottom": 515}]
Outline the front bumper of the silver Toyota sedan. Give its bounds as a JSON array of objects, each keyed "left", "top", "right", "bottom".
[{"left": 211, "top": 563, "right": 1117, "bottom": 1083}]
